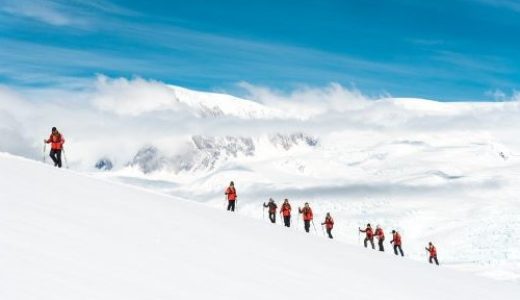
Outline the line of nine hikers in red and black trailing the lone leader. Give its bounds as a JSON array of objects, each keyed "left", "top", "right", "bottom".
[{"left": 225, "top": 181, "right": 439, "bottom": 265}]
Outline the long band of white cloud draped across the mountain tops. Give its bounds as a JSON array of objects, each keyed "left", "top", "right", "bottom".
[{"left": 0, "top": 76, "right": 520, "bottom": 168}]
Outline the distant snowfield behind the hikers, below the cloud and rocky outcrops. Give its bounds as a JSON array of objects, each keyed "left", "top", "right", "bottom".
[{"left": 104, "top": 130, "right": 520, "bottom": 282}]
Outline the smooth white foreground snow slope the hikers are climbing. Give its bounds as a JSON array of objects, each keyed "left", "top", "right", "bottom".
[{"left": 0, "top": 154, "right": 520, "bottom": 300}]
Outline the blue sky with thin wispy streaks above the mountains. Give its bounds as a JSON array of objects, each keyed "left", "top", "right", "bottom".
[{"left": 0, "top": 0, "right": 520, "bottom": 101}]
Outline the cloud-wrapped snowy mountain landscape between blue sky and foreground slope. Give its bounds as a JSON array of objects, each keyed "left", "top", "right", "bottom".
[{"left": 0, "top": 77, "right": 520, "bottom": 282}]
